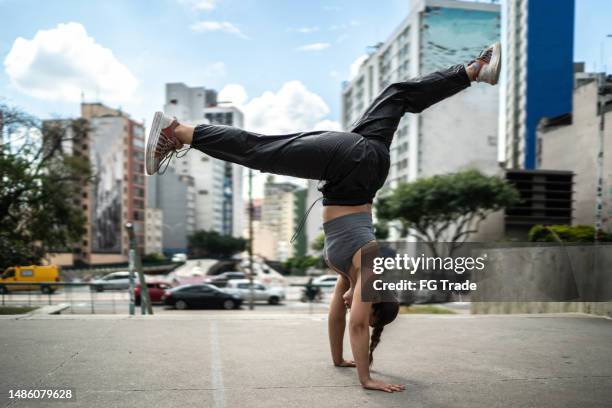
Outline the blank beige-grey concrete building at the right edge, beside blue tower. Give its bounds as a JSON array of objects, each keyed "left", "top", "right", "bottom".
[{"left": 536, "top": 72, "right": 612, "bottom": 232}]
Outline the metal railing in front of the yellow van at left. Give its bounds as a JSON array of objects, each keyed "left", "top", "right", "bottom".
[{"left": 0, "top": 282, "right": 136, "bottom": 314}]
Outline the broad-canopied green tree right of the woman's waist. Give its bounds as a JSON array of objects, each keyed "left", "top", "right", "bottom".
[{"left": 375, "top": 170, "right": 519, "bottom": 255}]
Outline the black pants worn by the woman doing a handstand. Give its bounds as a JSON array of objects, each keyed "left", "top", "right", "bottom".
[{"left": 192, "top": 65, "right": 470, "bottom": 205}]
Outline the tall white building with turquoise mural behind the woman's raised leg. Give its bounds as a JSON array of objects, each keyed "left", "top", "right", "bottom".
[{"left": 342, "top": 0, "right": 501, "bottom": 190}]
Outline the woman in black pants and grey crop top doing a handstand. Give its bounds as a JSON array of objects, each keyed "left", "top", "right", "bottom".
[{"left": 146, "top": 43, "right": 501, "bottom": 392}]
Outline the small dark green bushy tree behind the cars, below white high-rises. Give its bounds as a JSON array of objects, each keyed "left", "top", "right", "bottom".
[{"left": 187, "top": 230, "right": 247, "bottom": 258}]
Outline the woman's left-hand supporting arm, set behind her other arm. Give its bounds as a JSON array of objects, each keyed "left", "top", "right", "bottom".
[{"left": 327, "top": 275, "right": 355, "bottom": 367}]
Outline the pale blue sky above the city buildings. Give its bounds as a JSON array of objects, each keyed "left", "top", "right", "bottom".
[{"left": 0, "top": 0, "right": 612, "bottom": 129}]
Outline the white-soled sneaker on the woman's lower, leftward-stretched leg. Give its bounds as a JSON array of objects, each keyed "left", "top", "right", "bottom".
[{"left": 145, "top": 112, "right": 183, "bottom": 175}]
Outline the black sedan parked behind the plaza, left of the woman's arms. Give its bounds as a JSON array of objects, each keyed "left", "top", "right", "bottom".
[{"left": 162, "top": 284, "right": 242, "bottom": 310}]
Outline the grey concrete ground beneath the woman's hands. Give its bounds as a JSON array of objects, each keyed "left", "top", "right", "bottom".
[{"left": 0, "top": 311, "right": 612, "bottom": 408}]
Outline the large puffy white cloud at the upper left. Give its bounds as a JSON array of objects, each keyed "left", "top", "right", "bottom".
[{"left": 4, "top": 23, "right": 138, "bottom": 102}]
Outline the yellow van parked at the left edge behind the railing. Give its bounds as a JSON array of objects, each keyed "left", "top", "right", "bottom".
[{"left": 0, "top": 265, "right": 60, "bottom": 293}]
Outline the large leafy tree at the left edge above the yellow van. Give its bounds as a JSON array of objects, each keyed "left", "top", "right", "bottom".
[{"left": 0, "top": 104, "right": 91, "bottom": 269}]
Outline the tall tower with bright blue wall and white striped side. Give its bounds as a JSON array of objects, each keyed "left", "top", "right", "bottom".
[{"left": 505, "top": 0, "right": 574, "bottom": 169}]
